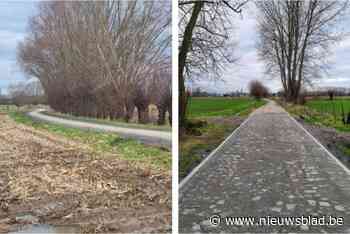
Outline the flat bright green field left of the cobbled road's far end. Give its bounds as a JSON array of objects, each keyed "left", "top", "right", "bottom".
[{"left": 188, "top": 97, "right": 266, "bottom": 118}]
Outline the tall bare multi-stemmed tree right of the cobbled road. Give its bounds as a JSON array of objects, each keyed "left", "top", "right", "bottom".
[{"left": 256, "top": 0, "right": 348, "bottom": 102}]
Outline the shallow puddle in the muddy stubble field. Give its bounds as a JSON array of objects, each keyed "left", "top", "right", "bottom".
[{"left": 9, "top": 224, "right": 80, "bottom": 234}]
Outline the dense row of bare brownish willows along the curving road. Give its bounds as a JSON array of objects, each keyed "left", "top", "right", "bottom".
[{"left": 17, "top": 0, "right": 171, "bottom": 124}]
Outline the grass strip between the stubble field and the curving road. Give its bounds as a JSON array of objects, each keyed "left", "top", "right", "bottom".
[{"left": 9, "top": 112, "right": 171, "bottom": 170}]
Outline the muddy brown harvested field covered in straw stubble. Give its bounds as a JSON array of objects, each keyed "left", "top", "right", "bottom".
[{"left": 0, "top": 114, "right": 171, "bottom": 233}]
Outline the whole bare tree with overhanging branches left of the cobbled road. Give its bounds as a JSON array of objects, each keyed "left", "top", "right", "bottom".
[{"left": 179, "top": 0, "right": 246, "bottom": 132}]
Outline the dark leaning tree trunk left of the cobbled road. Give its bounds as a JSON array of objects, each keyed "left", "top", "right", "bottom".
[{"left": 178, "top": 1, "right": 204, "bottom": 134}]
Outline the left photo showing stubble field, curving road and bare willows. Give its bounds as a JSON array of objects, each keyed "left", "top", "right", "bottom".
[{"left": 0, "top": 0, "right": 172, "bottom": 233}]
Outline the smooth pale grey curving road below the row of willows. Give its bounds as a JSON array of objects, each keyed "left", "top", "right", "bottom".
[{"left": 28, "top": 109, "right": 171, "bottom": 149}]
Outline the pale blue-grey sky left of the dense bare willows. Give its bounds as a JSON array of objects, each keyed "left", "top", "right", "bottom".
[{"left": 0, "top": 1, "right": 37, "bottom": 92}]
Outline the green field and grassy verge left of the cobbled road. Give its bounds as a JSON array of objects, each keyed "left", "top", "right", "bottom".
[{"left": 179, "top": 98, "right": 266, "bottom": 179}]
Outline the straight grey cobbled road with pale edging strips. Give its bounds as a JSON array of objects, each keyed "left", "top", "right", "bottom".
[{"left": 179, "top": 102, "right": 350, "bottom": 233}]
